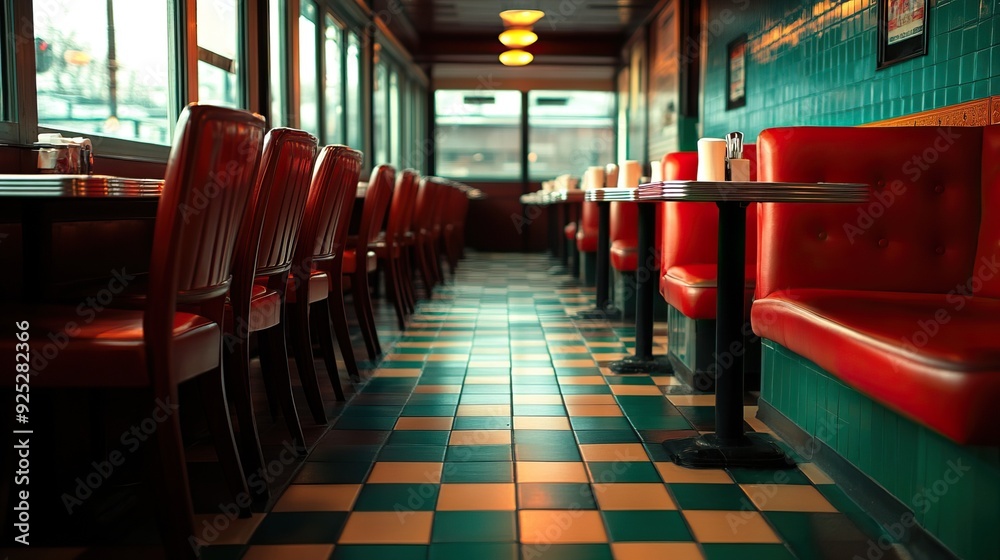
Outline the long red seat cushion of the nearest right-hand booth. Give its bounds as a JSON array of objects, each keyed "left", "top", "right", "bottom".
[{"left": 751, "top": 288, "right": 1000, "bottom": 445}]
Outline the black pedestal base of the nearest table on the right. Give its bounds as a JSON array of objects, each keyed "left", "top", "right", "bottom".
[{"left": 663, "top": 434, "right": 795, "bottom": 469}]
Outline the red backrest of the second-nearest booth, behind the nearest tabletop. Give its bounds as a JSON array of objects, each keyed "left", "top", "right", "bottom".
[{"left": 661, "top": 144, "right": 757, "bottom": 274}]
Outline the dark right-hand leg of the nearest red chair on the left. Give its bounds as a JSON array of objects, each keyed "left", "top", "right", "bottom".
[{"left": 198, "top": 368, "right": 250, "bottom": 518}]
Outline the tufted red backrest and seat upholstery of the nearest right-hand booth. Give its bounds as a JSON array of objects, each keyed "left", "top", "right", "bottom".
[{"left": 752, "top": 127, "right": 1000, "bottom": 444}]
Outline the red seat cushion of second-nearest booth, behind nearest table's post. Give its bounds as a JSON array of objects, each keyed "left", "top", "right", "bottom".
[{"left": 660, "top": 263, "right": 757, "bottom": 319}]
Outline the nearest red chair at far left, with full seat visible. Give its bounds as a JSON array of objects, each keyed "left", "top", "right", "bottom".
[{"left": 0, "top": 105, "right": 264, "bottom": 559}]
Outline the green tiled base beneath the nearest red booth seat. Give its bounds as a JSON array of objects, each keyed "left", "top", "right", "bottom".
[{"left": 761, "top": 340, "right": 1000, "bottom": 559}]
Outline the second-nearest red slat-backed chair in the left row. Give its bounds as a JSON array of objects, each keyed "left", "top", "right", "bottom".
[{"left": 226, "top": 128, "right": 322, "bottom": 494}]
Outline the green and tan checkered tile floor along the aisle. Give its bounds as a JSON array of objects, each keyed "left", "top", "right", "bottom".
[{"left": 191, "top": 255, "right": 912, "bottom": 560}]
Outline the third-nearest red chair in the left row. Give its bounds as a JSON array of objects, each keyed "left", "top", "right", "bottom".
[{"left": 288, "top": 146, "right": 361, "bottom": 394}]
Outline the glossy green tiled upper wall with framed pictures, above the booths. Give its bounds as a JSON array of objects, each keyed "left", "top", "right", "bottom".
[{"left": 702, "top": 0, "right": 1000, "bottom": 138}]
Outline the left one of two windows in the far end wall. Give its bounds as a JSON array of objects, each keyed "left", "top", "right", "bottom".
[{"left": 434, "top": 90, "right": 521, "bottom": 179}]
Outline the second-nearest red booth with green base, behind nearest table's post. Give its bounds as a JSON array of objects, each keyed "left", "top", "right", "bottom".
[{"left": 660, "top": 144, "right": 759, "bottom": 390}]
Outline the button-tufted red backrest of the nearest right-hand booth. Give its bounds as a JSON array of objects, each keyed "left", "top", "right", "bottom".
[{"left": 756, "top": 127, "right": 984, "bottom": 298}]
